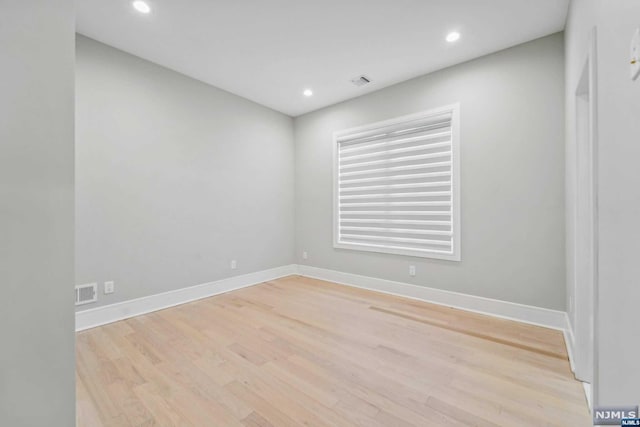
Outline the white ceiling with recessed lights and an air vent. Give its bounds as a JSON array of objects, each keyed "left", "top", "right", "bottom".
[{"left": 77, "top": 0, "right": 569, "bottom": 116}]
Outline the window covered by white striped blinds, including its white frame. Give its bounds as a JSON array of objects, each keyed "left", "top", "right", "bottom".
[{"left": 334, "top": 104, "right": 460, "bottom": 261}]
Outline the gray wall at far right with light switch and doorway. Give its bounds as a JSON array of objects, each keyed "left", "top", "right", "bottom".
[{"left": 567, "top": 0, "right": 640, "bottom": 405}]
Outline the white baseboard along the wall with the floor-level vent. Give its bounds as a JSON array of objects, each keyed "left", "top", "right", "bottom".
[{"left": 76, "top": 264, "right": 297, "bottom": 331}]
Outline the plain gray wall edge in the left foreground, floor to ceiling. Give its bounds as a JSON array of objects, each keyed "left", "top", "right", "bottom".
[{"left": 0, "top": 0, "right": 75, "bottom": 427}]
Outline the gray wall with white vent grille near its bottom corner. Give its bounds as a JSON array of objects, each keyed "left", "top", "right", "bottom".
[{"left": 76, "top": 36, "right": 294, "bottom": 309}]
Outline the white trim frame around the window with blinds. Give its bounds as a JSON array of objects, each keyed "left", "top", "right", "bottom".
[{"left": 333, "top": 103, "right": 461, "bottom": 261}]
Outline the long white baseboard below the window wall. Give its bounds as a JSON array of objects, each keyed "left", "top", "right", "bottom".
[{"left": 298, "top": 265, "right": 568, "bottom": 331}]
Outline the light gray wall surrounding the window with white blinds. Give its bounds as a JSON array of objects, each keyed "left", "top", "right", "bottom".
[{"left": 294, "top": 34, "right": 565, "bottom": 310}]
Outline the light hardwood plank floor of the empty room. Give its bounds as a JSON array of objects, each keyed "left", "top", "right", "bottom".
[{"left": 77, "top": 276, "right": 591, "bottom": 427}]
